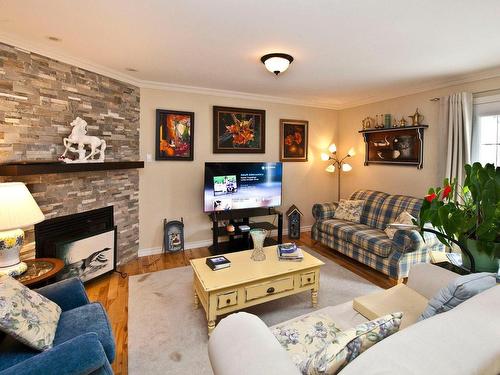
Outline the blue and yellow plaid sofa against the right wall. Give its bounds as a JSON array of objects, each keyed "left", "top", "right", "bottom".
[{"left": 311, "top": 190, "right": 444, "bottom": 279}]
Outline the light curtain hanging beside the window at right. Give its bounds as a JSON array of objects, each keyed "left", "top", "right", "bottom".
[{"left": 439, "top": 92, "right": 472, "bottom": 185}]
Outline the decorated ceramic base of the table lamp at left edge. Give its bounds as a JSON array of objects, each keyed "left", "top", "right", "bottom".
[{"left": 0, "top": 229, "right": 28, "bottom": 276}]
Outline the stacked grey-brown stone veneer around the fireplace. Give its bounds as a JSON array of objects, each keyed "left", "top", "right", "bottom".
[{"left": 0, "top": 43, "right": 140, "bottom": 263}]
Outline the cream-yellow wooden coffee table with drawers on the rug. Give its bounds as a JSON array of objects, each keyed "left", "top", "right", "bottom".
[{"left": 190, "top": 246, "right": 324, "bottom": 335}]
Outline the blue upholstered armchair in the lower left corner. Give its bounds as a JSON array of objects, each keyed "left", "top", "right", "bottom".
[{"left": 0, "top": 278, "right": 115, "bottom": 375}]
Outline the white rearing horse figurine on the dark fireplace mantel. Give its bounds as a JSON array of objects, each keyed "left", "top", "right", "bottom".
[{"left": 60, "top": 117, "right": 106, "bottom": 163}]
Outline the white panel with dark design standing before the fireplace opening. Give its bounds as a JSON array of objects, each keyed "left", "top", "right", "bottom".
[{"left": 55, "top": 227, "right": 116, "bottom": 282}]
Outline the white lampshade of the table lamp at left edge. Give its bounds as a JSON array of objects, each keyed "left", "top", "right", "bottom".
[{"left": 0, "top": 182, "right": 45, "bottom": 231}]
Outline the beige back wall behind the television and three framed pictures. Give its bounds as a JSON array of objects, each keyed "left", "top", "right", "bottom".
[{"left": 139, "top": 89, "right": 337, "bottom": 250}]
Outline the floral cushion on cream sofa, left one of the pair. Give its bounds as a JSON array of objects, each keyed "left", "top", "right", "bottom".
[{"left": 273, "top": 314, "right": 340, "bottom": 366}]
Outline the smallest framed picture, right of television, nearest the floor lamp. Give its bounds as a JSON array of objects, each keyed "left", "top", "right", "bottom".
[{"left": 280, "top": 120, "right": 309, "bottom": 161}]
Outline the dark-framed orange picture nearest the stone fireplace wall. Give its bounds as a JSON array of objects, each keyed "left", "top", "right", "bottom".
[{"left": 156, "top": 109, "right": 194, "bottom": 160}]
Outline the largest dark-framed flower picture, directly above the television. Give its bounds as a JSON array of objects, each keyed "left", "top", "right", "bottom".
[{"left": 213, "top": 106, "right": 266, "bottom": 154}]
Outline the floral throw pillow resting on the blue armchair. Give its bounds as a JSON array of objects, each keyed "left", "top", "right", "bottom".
[{"left": 0, "top": 276, "right": 61, "bottom": 350}]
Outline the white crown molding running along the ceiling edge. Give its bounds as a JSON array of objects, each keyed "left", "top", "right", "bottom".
[{"left": 0, "top": 32, "right": 500, "bottom": 110}]
